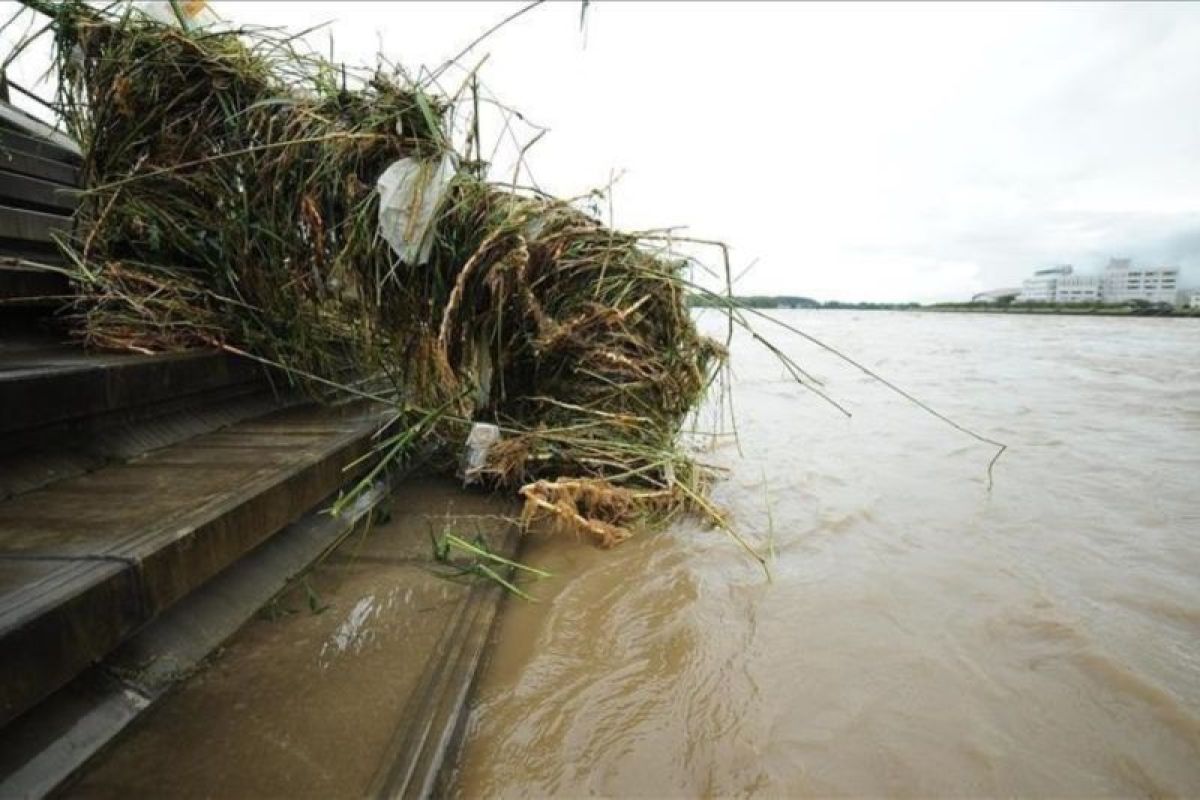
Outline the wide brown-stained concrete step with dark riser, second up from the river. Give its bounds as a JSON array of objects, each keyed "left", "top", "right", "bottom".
[{"left": 0, "top": 400, "right": 380, "bottom": 726}]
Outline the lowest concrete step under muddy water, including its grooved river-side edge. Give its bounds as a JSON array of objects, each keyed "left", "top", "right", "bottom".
[{"left": 24, "top": 477, "right": 516, "bottom": 798}]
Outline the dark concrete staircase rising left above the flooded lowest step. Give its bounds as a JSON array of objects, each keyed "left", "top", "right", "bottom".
[{"left": 0, "top": 97, "right": 396, "bottom": 796}]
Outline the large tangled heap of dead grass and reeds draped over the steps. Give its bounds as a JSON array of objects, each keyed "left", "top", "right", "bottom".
[{"left": 29, "top": 0, "right": 724, "bottom": 545}]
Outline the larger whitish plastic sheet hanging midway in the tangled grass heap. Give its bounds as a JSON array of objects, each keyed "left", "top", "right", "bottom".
[{"left": 376, "top": 152, "right": 458, "bottom": 265}]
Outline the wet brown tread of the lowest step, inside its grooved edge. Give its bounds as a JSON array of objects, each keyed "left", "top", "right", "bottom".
[{"left": 64, "top": 480, "right": 515, "bottom": 798}]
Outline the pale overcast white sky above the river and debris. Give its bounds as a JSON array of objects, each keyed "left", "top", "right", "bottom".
[{"left": 5, "top": 0, "right": 1200, "bottom": 301}]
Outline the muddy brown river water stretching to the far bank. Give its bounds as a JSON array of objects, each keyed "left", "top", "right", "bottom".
[{"left": 457, "top": 311, "right": 1200, "bottom": 796}]
